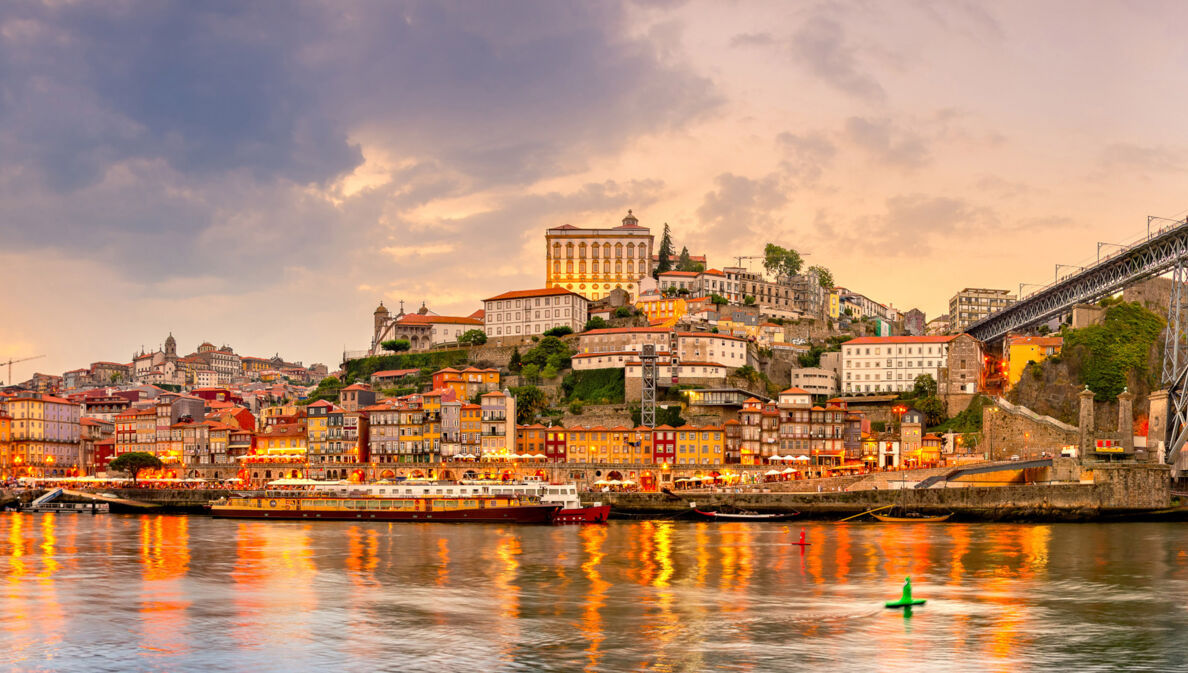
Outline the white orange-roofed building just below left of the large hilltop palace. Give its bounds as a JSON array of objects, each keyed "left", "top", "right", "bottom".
[{"left": 482, "top": 287, "right": 589, "bottom": 339}]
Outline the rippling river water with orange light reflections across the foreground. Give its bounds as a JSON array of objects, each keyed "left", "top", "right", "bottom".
[{"left": 0, "top": 514, "right": 1188, "bottom": 673}]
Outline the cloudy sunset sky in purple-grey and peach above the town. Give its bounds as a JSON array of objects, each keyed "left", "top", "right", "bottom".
[{"left": 0, "top": 0, "right": 1188, "bottom": 380}]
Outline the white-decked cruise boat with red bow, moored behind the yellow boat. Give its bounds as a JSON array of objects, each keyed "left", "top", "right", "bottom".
[{"left": 310, "top": 482, "right": 611, "bottom": 523}]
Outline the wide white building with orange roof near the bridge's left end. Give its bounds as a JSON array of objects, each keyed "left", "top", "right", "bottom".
[{"left": 841, "top": 337, "right": 954, "bottom": 394}]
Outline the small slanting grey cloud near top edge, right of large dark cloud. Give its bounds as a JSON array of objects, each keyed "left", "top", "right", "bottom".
[{"left": 791, "top": 13, "right": 886, "bottom": 102}]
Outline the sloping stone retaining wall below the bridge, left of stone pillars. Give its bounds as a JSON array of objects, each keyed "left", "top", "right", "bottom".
[{"left": 981, "top": 400, "right": 1080, "bottom": 460}]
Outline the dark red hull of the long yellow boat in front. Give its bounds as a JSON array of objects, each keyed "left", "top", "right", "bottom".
[{"left": 210, "top": 505, "right": 561, "bottom": 523}]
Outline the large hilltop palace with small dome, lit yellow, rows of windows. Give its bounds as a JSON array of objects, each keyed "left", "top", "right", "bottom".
[{"left": 544, "top": 210, "right": 652, "bottom": 300}]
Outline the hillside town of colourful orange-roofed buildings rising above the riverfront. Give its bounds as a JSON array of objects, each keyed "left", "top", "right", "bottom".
[{"left": 0, "top": 210, "right": 1164, "bottom": 490}]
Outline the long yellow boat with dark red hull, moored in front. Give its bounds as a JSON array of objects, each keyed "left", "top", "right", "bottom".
[{"left": 210, "top": 491, "right": 561, "bottom": 523}]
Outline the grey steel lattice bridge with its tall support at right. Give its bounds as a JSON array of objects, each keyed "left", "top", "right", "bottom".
[{"left": 966, "top": 218, "right": 1188, "bottom": 473}]
